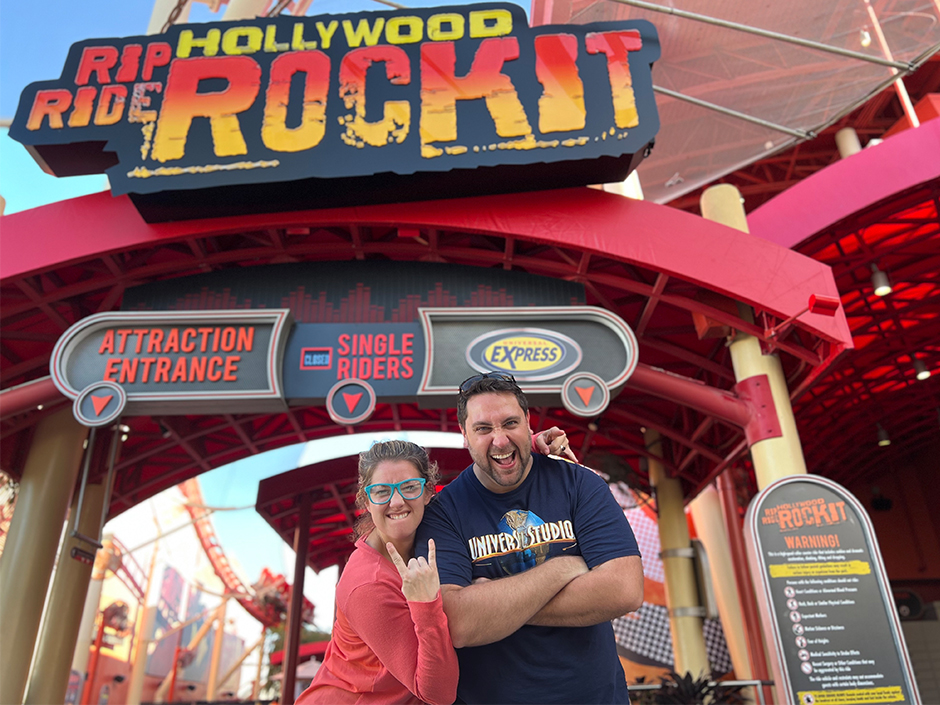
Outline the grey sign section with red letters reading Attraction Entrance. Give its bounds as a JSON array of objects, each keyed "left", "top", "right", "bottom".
[{"left": 49, "top": 310, "right": 290, "bottom": 415}]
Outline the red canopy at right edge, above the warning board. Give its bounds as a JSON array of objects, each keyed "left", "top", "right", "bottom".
[{"left": 748, "top": 120, "right": 940, "bottom": 484}]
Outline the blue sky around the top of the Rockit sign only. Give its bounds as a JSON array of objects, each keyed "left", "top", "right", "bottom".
[{"left": 0, "top": 0, "right": 529, "bottom": 214}]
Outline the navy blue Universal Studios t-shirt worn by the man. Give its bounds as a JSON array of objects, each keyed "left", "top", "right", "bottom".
[{"left": 415, "top": 455, "right": 640, "bottom": 703}]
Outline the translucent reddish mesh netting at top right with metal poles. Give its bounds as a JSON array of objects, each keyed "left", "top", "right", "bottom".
[{"left": 531, "top": 0, "right": 940, "bottom": 203}]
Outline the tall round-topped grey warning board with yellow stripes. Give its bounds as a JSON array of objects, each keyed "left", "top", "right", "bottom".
[{"left": 745, "top": 475, "right": 920, "bottom": 705}]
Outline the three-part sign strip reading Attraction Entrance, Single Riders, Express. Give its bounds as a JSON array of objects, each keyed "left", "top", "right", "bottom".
[{"left": 50, "top": 306, "right": 637, "bottom": 425}]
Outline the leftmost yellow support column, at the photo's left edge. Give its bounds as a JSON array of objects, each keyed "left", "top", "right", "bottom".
[{"left": 0, "top": 406, "right": 88, "bottom": 705}]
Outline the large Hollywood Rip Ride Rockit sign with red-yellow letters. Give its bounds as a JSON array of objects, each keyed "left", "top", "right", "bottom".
[{"left": 10, "top": 3, "right": 659, "bottom": 219}]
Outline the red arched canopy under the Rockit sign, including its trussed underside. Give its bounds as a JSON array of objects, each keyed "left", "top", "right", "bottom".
[{"left": 0, "top": 189, "right": 852, "bottom": 515}]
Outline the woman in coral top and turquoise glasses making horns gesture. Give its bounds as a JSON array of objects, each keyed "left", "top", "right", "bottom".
[{"left": 297, "top": 441, "right": 457, "bottom": 705}]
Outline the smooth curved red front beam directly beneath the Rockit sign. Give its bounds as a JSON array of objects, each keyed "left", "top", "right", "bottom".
[{"left": 0, "top": 188, "right": 852, "bottom": 348}]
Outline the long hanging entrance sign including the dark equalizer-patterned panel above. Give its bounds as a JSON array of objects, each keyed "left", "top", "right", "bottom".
[{"left": 50, "top": 261, "right": 638, "bottom": 426}]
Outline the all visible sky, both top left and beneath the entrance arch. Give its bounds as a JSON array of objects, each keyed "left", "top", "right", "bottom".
[{"left": 0, "top": 0, "right": 488, "bottom": 628}]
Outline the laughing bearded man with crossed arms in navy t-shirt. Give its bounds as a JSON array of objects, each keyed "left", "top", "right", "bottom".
[{"left": 417, "top": 372, "right": 643, "bottom": 703}]
